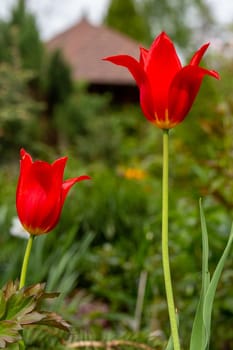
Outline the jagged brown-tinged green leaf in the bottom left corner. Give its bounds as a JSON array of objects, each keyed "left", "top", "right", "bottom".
[{"left": 0, "top": 282, "right": 70, "bottom": 348}]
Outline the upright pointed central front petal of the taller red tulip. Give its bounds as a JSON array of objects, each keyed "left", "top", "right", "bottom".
[{"left": 144, "top": 32, "right": 181, "bottom": 119}]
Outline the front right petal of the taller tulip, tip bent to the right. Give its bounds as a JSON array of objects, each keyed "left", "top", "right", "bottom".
[{"left": 168, "top": 65, "right": 219, "bottom": 127}]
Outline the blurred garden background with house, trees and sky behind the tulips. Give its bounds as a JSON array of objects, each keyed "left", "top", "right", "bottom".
[{"left": 0, "top": 0, "right": 233, "bottom": 350}]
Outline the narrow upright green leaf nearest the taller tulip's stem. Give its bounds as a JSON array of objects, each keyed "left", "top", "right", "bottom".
[{"left": 190, "top": 199, "right": 210, "bottom": 350}]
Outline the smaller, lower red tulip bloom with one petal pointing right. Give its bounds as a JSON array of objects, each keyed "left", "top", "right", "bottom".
[{"left": 16, "top": 149, "right": 90, "bottom": 235}]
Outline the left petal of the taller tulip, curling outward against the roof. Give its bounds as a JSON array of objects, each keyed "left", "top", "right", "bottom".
[{"left": 104, "top": 55, "right": 145, "bottom": 86}]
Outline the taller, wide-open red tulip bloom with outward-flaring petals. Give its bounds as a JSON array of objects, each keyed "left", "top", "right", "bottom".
[{"left": 104, "top": 32, "right": 219, "bottom": 129}]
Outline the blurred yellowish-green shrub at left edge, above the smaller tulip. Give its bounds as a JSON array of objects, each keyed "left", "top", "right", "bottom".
[{"left": 0, "top": 63, "right": 42, "bottom": 162}]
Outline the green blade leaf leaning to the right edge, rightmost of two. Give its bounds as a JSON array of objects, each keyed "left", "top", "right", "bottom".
[{"left": 203, "top": 224, "right": 233, "bottom": 348}]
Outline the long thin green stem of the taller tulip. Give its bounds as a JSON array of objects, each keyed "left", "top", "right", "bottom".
[{"left": 162, "top": 130, "right": 180, "bottom": 350}]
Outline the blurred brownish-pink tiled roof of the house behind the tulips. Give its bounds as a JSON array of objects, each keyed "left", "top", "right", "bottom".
[{"left": 46, "top": 19, "right": 139, "bottom": 85}]
